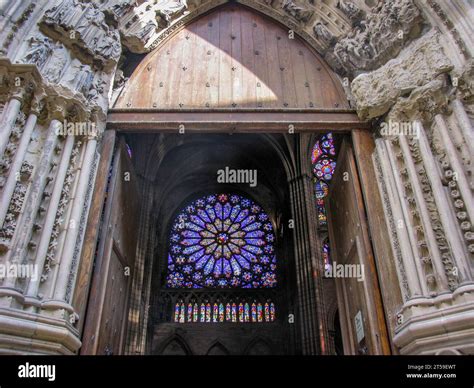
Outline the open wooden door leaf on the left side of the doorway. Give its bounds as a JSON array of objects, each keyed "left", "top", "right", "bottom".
[{"left": 81, "top": 140, "right": 140, "bottom": 354}]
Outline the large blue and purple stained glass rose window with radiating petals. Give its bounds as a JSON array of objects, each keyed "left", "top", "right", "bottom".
[{"left": 166, "top": 194, "right": 277, "bottom": 288}]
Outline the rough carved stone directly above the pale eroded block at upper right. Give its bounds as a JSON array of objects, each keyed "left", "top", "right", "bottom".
[{"left": 333, "top": 0, "right": 423, "bottom": 75}]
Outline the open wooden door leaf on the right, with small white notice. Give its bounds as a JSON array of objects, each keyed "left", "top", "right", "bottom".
[{"left": 327, "top": 139, "right": 390, "bottom": 354}]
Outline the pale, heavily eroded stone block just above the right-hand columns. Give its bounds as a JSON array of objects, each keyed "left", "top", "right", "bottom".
[{"left": 351, "top": 32, "right": 453, "bottom": 119}]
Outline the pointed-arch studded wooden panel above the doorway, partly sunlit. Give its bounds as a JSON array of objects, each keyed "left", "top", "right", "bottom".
[{"left": 115, "top": 4, "right": 348, "bottom": 109}]
